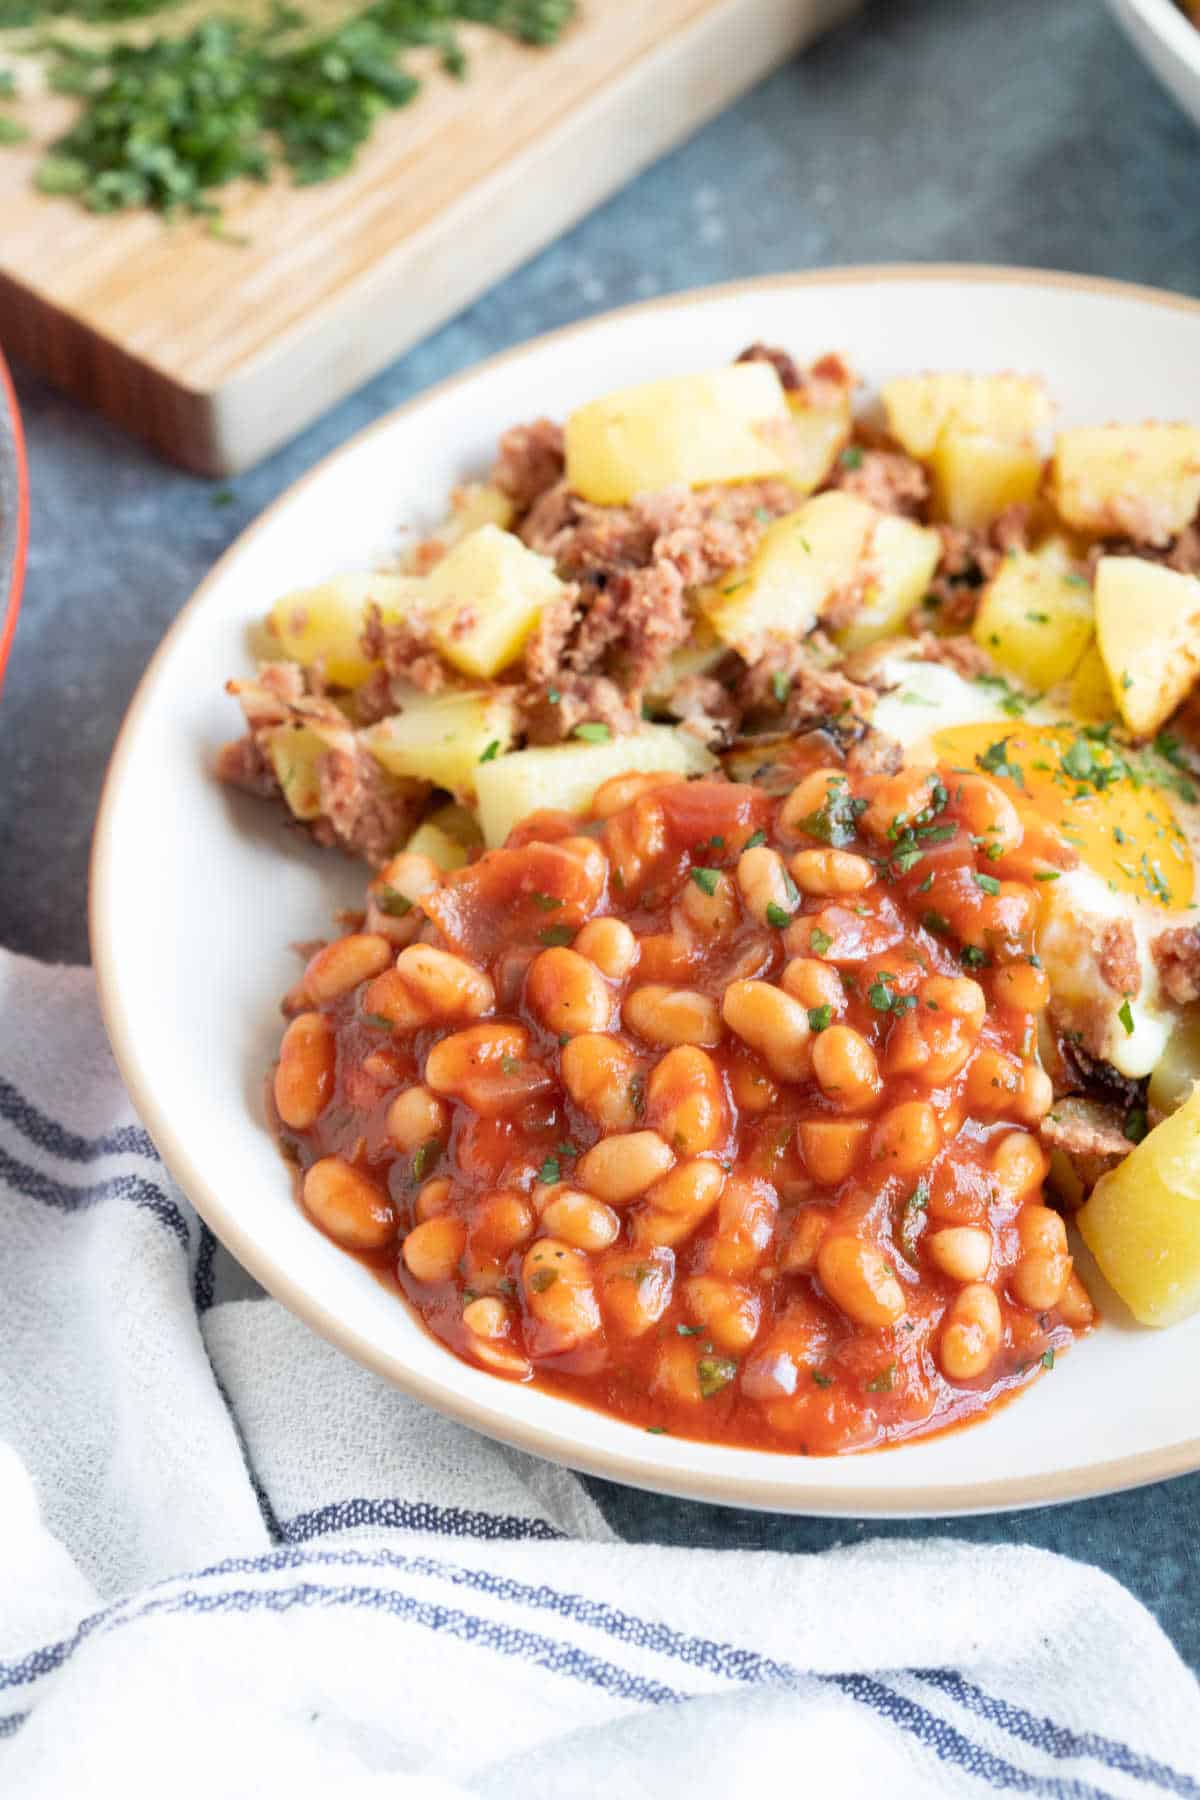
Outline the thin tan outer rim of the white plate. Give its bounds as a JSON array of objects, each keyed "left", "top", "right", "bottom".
[{"left": 96, "top": 263, "right": 1200, "bottom": 1519}]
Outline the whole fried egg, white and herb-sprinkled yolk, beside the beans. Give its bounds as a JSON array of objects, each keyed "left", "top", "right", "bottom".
[{"left": 874, "top": 652, "right": 1200, "bottom": 1078}]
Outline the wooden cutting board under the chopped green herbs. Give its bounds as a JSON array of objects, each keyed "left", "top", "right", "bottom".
[{"left": 0, "top": 0, "right": 858, "bottom": 475}]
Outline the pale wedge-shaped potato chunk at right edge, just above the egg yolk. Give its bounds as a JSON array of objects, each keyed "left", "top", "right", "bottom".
[{"left": 1096, "top": 556, "right": 1200, "bottom": 738}]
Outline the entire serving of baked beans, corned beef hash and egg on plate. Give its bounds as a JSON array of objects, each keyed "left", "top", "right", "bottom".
[{"left": 219, "top": 344, "right": 1200, "bottom": 1454}]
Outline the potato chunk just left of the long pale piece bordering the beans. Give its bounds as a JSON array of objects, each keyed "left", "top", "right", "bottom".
[{"left": 365, "top": 689, "right": 515, "bottom": 799}]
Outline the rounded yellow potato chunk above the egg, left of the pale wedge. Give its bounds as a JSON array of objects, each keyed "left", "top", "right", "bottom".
[{"left": 972, "top": 549, "right": 1094, "bottom": 691}]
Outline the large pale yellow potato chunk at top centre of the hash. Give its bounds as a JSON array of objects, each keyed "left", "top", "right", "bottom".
[{"left": 565, "top": 362, "right": 790, "bottom": 506}]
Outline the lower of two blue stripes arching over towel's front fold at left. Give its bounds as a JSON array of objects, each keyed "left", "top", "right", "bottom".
[{"left": 0, "top": 1582, "right": 685, "bottom": 1706}]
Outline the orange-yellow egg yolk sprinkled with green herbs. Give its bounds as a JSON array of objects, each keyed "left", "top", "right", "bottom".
[{"left": 932, "top": 724, "right": 1195, "bottom": 909}]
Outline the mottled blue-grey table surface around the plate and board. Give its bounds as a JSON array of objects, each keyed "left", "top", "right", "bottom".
[{"left": 0, "top": 0, "right": 1200, "bottom": 1669}]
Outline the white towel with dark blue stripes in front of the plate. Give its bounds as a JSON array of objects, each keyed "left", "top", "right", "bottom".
[{"left": 0, "top": 954, "right": 1200, "bottom": 1800}]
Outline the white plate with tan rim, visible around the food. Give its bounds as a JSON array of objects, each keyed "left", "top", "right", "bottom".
[{"left": 92, "top": 268, "right": 1200, "bottom": 1516}]
